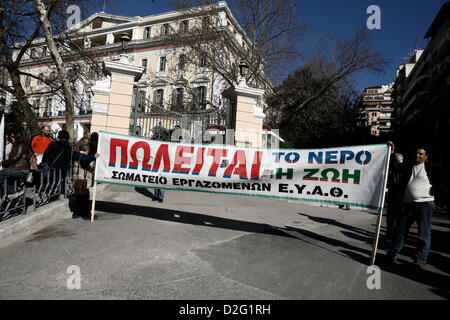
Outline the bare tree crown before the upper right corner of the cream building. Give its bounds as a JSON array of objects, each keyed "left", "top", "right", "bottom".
[{"left": 146, "top": 0, "right": 303, "bottom": 109}]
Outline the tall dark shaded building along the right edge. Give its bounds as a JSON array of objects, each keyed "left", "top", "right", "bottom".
[{"left": 393, "top": 2, "right": 450, "bottom": 162}]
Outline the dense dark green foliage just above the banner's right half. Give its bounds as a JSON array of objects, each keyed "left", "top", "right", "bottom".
[{"left": 269, "top": 67, "right": 353, "bottom": 148}]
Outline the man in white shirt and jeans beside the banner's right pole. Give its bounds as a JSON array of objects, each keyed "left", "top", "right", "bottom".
[{"left": 388, "top": 148, "right": 437, "bottom": 268}]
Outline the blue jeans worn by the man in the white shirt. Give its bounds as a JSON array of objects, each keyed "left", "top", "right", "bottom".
[{"left": 390, "top": 201, "right": 436, "bottom": 262}]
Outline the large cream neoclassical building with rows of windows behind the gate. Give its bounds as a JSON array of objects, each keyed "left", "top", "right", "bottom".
[{"left": 7, "top": 1, "right": 270, "bottom": 138}]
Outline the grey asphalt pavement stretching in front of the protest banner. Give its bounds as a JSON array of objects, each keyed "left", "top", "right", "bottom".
[{"left": 0, "top": 186, "right": 450, "bottom": 300}]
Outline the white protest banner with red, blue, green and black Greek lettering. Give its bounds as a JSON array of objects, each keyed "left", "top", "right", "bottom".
[{"left": 95, "top": 132, "right": 389, "bottom": 210}]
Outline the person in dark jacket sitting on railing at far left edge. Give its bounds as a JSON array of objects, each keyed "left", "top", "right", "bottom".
[{"left": 0, "top": 131, "right": 31, "bottom": 194}]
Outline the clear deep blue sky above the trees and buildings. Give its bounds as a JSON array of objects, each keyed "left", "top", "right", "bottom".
[{"left": 100, "top": 0, "right": 447, "bottom": 91}]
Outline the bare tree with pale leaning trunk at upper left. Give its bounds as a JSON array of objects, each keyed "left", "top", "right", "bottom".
[{"left": 0, "top": 0, "right": 107, "bottom": 136}]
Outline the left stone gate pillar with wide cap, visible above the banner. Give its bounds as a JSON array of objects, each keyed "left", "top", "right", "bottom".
[{"left": 91, "top": 56, "right": 144, "bottom": 135}]
